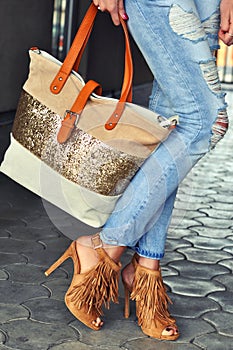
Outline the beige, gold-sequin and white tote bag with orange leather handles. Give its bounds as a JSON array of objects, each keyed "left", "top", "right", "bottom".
[{"left": 0, "top": 4, "right": 177, "bottom": 227}]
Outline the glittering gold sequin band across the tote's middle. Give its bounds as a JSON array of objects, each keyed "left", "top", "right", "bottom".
[{"left": 12, "top": 91, "right": 144, "bottom": 195}]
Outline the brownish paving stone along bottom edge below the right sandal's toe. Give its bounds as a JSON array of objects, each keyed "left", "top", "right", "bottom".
[{"left": 124, "top": 338, "right": 200, "bottom": 350}]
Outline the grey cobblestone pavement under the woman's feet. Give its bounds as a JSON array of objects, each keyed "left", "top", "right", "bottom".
[{"left": 0, "top": 85, "right": 233, "bottom": 350}]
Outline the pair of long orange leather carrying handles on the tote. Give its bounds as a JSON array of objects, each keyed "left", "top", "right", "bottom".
[{"left": 50, "top": 3, "right": 133, "bottom": 130}]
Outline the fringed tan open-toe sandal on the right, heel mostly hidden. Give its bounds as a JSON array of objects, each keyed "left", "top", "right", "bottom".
[{"left": 123, "top": 254, "right": 179, "bottom": 340}]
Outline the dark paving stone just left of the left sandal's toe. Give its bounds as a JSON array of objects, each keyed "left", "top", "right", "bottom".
[{"left": 22, "top": 298, "right": 75, "bottom": 324}]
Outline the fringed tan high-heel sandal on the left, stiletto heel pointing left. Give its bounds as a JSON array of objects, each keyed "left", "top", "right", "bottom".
[{"left": 45, "top": 234, "right": 121, "bottom": 331}]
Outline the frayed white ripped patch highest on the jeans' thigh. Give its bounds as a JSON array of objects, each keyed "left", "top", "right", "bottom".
[{"left": 169, "top": 5, "right": 206, "bottom": 42}]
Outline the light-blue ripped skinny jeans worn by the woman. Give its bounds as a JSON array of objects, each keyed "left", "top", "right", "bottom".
[{"left": 100, "top": 0, "right": 228, "bottom": 259}]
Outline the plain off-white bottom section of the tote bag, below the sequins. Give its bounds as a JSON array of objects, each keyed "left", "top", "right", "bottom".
[{"left": 0, "top": 134, "right": 120, "bottom": 227}]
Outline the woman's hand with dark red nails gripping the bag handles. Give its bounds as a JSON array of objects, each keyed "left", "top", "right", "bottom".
[{"left": 93, "top": 0, "right": 128, "bottom": 26}]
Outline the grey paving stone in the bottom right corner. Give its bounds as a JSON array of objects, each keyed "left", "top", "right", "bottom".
[{"left": 194, "top": 333, "right": 232, "bottom": 350}]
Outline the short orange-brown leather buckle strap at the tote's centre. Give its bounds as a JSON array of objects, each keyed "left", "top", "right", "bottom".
[{"left": 57, "top": 80, "right": 102, "bottom": 143}]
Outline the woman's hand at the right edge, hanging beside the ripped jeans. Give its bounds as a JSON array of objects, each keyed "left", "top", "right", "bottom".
[{"left": 218, "top": 0, "right": 233, "bottom": 46}]
